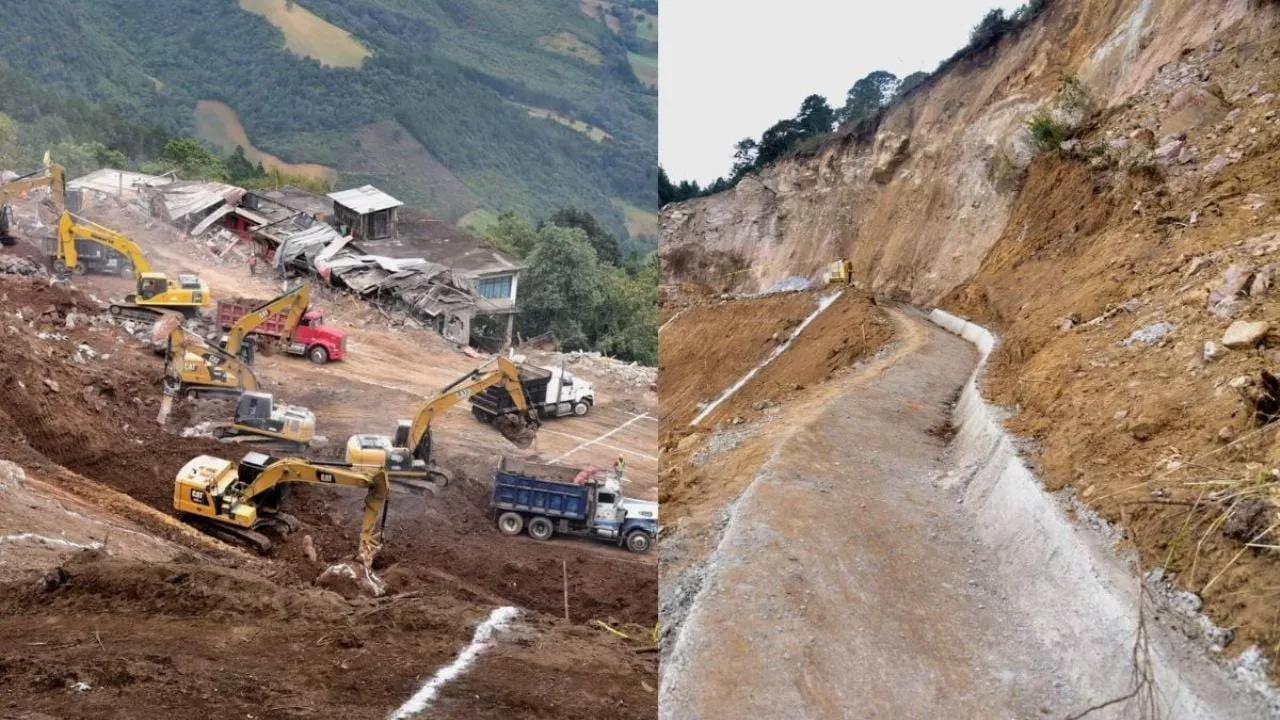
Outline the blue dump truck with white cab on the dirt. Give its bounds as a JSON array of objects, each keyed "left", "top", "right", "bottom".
[{"left": 489, "top": 456, "right": 658, "bottom": 552}]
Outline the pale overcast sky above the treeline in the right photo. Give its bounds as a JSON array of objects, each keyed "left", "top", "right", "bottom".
[{"left": 658, "top": 0, "right": 1023, "bottom": 184}]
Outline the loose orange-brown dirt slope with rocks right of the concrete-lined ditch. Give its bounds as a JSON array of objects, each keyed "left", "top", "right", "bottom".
[{"left": 942, "top": 27, "right": 1280, "bottom": 679}]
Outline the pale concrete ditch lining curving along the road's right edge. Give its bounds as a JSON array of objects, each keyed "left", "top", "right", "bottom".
[{"left": 929, "top": 304, "right": 1280, "bottom": 719}]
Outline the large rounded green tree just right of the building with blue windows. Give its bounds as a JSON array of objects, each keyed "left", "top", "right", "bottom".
[{"left": 520, "top": 224, "right": 604, "bottom": 350}]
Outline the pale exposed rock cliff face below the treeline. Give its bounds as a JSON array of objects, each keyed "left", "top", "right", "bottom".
[{"left": 660, "top": 0, "right": 1249, "bottom": 304}]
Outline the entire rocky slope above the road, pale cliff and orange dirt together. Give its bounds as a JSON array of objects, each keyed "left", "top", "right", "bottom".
[{"left": 662, "top": 0, "right": 1280, "bottom": 680}]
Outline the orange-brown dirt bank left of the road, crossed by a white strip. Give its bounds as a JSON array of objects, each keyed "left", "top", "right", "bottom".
[{"left": 659, "top": 283, "right": 893, "bottom": 532}]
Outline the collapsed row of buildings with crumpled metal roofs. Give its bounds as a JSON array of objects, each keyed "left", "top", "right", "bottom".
[{"left": 63, "top": 170, "right": 524, "bottom": 348}]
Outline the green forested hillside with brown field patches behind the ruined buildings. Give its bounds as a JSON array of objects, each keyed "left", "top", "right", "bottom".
[{"left": 0, "top": 0, "right": 657, "bottom": 252}]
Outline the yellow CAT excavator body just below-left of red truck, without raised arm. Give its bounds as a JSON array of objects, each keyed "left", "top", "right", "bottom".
[{"left": 151, "top": 313, "right": 261, "bottom": 400}]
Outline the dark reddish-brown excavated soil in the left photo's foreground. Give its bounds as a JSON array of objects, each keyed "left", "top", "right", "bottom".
[{"left": 0, "top": 277, "right": 657, "bottom": 720}]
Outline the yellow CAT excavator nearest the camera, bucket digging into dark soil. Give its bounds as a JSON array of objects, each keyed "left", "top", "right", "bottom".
[{"left": 173, "top": 452, "right": 390, "bottom": 568}]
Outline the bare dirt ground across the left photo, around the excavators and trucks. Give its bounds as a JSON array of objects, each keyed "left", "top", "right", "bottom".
[{"left": 0, "top": 194, "right": 657, "bottom": 719}]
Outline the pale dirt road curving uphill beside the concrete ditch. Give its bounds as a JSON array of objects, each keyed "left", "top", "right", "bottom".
[{"left": 660, "top": 311, "right": 1074, "bottom": 720}]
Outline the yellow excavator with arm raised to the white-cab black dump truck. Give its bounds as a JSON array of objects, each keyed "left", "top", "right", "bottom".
[{"left": 347, "top": 356, "right": 539, "bottom": 492}]
